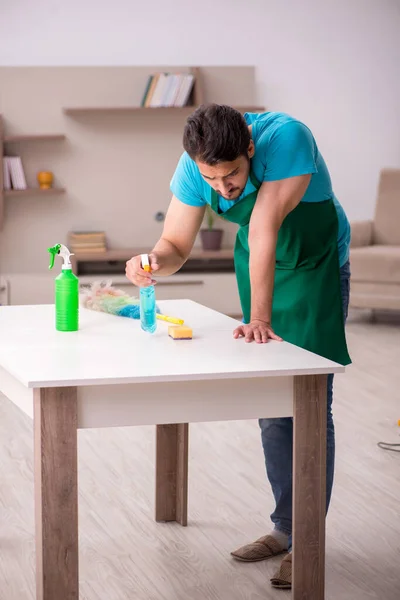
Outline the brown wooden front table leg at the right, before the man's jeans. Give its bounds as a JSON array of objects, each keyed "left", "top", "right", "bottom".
[{"left": 292, "top": 375, "right": 327, "bottom": 600}]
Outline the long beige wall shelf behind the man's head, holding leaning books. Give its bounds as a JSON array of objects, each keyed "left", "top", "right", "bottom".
[{"left": 63, "top": 105, "right": 265, "bottom": 116}]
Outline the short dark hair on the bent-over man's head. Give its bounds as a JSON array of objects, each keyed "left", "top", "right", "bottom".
[{"left": 183, "top": 104, "right": 250, "bottom": 165}]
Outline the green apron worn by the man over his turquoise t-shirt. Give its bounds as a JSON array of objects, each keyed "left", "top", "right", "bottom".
[{"left": 211, "top": 172, "right": 351, "bottom": 365}]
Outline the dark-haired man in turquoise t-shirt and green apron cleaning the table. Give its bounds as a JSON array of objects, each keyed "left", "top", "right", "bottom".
[{"left": 126, "top": 104, "right": 350, "bottom": 588}]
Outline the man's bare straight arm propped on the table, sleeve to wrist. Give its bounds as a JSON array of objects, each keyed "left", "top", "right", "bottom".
[{"left": 249, "top": 175, "right": 311, "bottom": 324}]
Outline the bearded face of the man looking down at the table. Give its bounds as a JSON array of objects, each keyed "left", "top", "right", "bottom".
[{"left": 196, "top": 147, "right": 254, "bottom": 200}]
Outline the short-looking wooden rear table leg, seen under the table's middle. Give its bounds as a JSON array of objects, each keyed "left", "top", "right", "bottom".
[{"left": 156, "top": 423, "right": 189, "bottom": 526}]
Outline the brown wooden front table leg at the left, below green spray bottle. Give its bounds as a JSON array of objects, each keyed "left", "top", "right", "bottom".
[{"left": 34, "top": 387, "right": 79, "bottom": 600}]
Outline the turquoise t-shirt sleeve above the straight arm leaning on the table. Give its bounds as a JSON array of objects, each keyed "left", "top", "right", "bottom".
[{"left": 257, "top": 121, "right": 317, "bottom": 181}]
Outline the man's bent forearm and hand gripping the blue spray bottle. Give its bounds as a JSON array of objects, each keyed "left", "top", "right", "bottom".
[{"left": 125, "top": 196, "right": 205, "bottom": 286}]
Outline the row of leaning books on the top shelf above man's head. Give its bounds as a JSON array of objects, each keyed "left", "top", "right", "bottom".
[{"left": 142, "top": 73, "right": 194, "bottom": 108}]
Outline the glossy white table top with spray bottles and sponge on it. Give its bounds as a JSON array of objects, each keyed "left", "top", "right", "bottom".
[{"left": 0, "top": 300, "right": 344, "bottom": 388}]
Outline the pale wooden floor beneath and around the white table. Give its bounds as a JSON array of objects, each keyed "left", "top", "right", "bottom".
[{"left": 0, "top": 317, "right": 400, "bottom": 600}]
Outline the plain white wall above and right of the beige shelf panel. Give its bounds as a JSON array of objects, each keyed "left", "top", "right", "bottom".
[{"left": 0, "top": 0, "right": 400, "bottom": 219}]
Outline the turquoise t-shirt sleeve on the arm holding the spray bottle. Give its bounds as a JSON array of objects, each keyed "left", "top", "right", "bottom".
[{"left": 170, "top": 152, "right": 206, "bottom": 206}]
